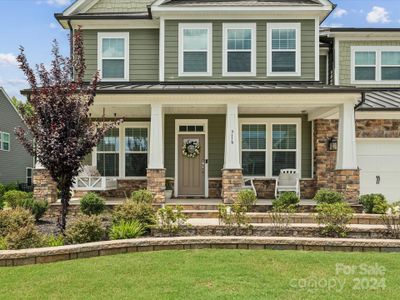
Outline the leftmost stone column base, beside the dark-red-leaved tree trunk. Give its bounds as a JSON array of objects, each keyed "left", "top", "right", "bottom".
[{"left": 33, "top": 169, "right": 57, "bottom": 203}]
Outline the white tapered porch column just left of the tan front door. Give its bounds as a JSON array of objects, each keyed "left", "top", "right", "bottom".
[{"left": 148, "top": 103, "right": 164, "bottom": 169}]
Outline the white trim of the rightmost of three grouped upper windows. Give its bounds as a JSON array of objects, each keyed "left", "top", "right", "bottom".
[{"left": 267, "top": 23, "right": 301, "bottom": 77}]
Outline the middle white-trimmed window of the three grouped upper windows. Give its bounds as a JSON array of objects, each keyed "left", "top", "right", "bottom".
[{"left": 223, "top": 23, "right": 257, "bottom": 76}]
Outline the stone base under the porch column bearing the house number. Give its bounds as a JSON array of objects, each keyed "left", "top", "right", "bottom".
[{"left": 222, "top": 169, "right": 243, "bottom": 203}]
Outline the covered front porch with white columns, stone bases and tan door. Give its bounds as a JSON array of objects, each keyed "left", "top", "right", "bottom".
[{"left": 32, "top": 82, "right": 360, "bottom": 203}]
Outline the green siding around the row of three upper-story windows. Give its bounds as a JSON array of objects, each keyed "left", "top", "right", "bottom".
[{"left": 165, "top": 20, "right": 315, "bottom": 81}]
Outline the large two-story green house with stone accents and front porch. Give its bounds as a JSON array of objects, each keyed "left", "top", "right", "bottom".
[{"left": 45, "top": 0, "right": 400, "bottom": 202}]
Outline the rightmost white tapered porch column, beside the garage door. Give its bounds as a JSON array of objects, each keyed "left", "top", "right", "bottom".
[{"left": 336, "top": 103, "right": 357, "bottom": 170}]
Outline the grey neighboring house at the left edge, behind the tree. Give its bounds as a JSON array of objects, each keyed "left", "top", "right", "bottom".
[{"left": 0, "top": 87, "right": 33, "bottom": 186}]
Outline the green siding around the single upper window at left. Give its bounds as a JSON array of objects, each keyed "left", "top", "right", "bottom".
[{"left": 82, "top": 29, "right": 159, "bottom": 81}]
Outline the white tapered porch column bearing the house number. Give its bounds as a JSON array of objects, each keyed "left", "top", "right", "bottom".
[{"left": 224, "top": 104, "right": 241, "bottom": 170}]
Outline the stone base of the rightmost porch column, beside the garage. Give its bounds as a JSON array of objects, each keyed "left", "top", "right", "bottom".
[{"left": 335, "top": 170, "right": 360, "bottom": 203}]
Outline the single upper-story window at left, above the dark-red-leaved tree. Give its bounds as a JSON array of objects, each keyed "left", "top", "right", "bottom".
[{"left": 98, "top": 32, "right": 129, "bottom": 81}]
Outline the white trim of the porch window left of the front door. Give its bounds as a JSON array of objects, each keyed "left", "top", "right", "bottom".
[{"left": 92, "top": 122, "right": 150, "bottom": 180}]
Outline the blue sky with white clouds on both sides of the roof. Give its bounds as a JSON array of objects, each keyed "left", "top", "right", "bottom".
[{"left": 0, "top": 0, "right": 400, "bottom": 100}]
